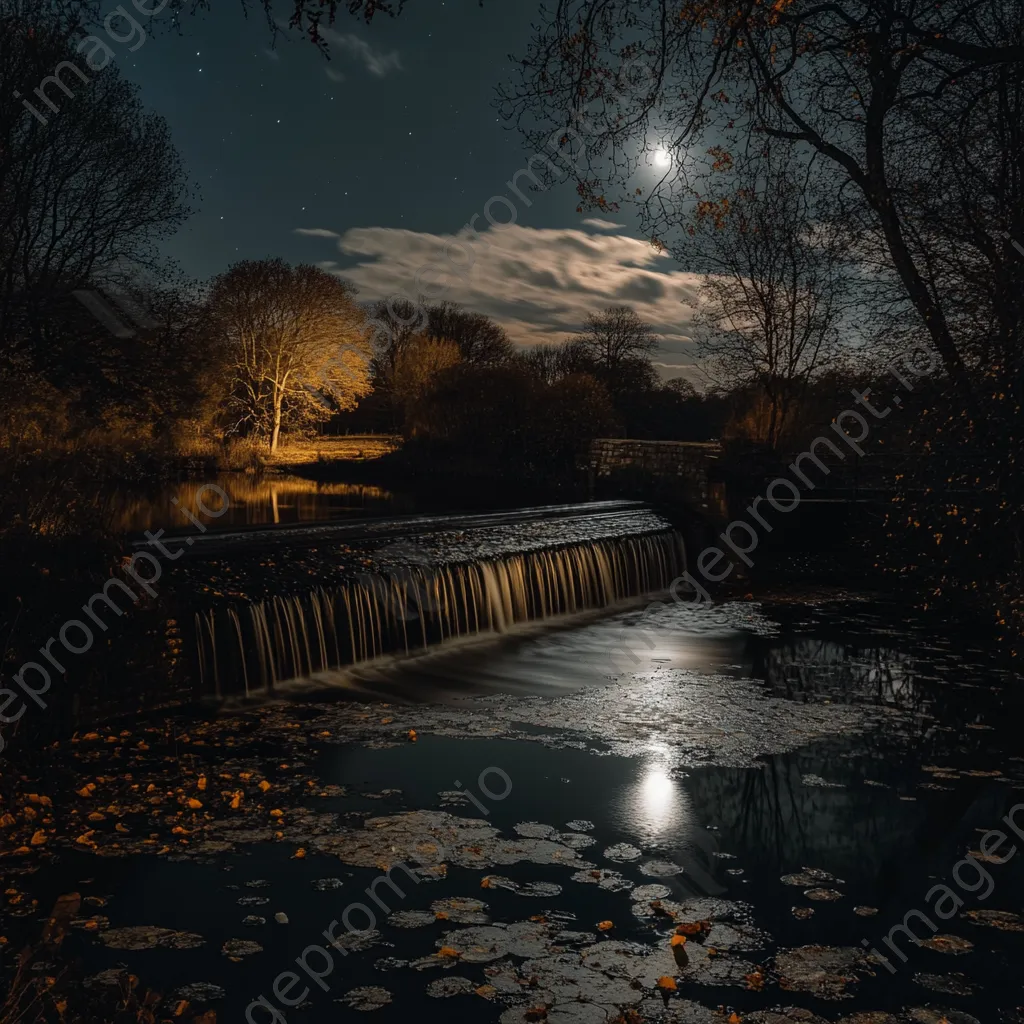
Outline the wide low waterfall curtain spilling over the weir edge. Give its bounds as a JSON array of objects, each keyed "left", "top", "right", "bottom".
[{"left": 196, "top": 530, "right": 686, "bottom": 697}]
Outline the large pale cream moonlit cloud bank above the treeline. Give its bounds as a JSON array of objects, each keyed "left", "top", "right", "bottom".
[{"left": 297, "top": 224, "right": 700, "bottom": 376}]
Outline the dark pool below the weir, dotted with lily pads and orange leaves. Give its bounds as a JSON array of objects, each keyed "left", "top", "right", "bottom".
[{"left": 6, "top": 496, "right": 1024, "bottom": 1024}]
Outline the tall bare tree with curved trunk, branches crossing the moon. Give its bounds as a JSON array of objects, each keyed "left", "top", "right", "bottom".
[{"left": 500, "top": 0, "right": 1024, "bottom": 392}]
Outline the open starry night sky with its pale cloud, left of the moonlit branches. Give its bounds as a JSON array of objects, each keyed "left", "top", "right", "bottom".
[{"left": 117, "top": 0, "right": 697, "bottom": 377}]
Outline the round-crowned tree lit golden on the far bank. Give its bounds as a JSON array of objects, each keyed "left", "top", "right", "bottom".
[{"left": 210, "top": 259, "right": 371, "bottom": 452}]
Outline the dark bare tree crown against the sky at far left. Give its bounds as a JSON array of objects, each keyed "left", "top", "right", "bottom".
[{"left": 0, "top": 6, "right": 189, "bottom": 368}]
